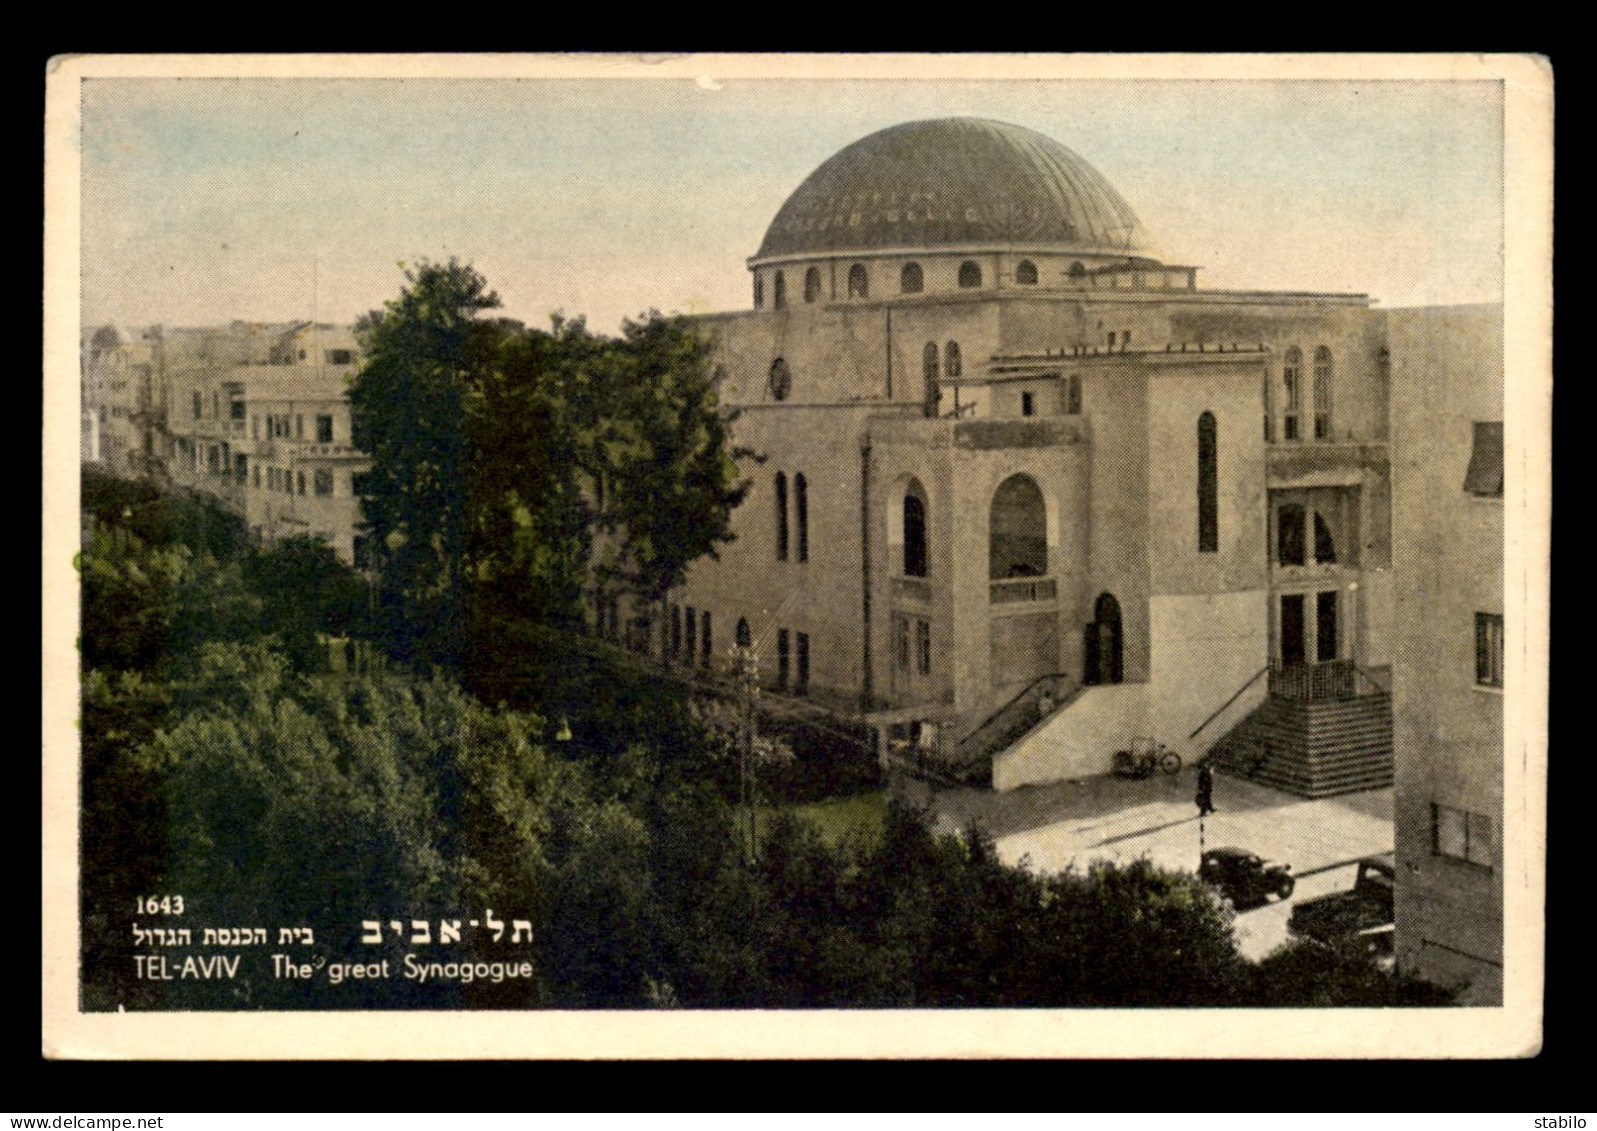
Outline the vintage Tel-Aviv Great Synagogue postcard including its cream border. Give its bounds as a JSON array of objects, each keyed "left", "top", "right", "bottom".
[{"left": 45, "top": 56, "right": 1552, "bottom": 1056}]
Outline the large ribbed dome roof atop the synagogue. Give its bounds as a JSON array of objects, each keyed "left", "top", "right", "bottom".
[{"left": 754, "top": 118, "right": 1156, "bottom": 259}]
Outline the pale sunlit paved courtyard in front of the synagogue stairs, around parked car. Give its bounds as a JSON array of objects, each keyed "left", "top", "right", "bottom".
[{"left": 901, "top": 768, "right": 1393, "bottom": 958}]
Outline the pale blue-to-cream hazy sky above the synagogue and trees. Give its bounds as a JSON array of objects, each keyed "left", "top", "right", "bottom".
[{"left": 80, "top": 65, "right": 1503, "bottom": 331}]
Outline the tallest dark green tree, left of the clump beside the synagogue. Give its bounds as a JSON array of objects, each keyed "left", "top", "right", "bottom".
[{"left": 350, "top": 260, "right": 500, "bottom": 671}]
